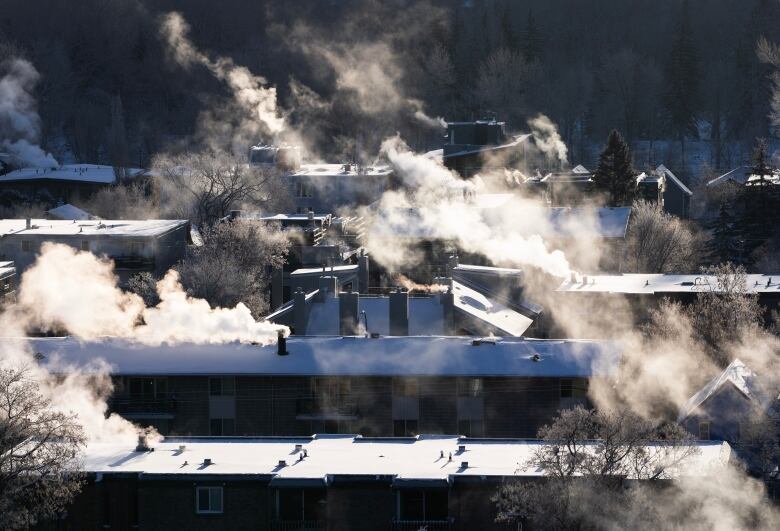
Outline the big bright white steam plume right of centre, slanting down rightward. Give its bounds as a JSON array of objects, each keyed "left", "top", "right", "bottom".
[{"left": 365, "top": 137, "right": 597, "bottom": 277}]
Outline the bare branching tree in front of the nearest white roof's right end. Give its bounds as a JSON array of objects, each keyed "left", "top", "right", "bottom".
[{"left": 493, "top": 406, "right": 698, "bottom": 529}]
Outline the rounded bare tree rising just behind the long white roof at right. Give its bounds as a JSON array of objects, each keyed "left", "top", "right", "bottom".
[{"left": 626, "top": 200, "right": 704, "bottom": 273}]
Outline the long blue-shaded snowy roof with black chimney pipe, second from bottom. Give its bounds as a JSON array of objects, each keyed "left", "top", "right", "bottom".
[{"left": 25, "top": 336, "right": 620, "bottom": 378}]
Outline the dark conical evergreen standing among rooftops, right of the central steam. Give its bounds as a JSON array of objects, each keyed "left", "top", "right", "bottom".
[{"left": 593, "top": 129, "right": 637, "bottom": 206}]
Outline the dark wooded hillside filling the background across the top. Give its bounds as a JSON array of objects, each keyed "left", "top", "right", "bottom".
[{"left": 0, "top": 0, "right": 780, "bottom": 167}]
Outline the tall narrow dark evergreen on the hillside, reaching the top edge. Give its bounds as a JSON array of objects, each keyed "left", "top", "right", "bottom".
[{"left": 664, "top": 0, "right": 699, "bottom": 143}]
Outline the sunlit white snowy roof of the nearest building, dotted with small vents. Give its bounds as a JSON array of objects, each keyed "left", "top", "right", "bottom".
[{"left": 82, "top": 435, "right": 731, "bottom": 487}]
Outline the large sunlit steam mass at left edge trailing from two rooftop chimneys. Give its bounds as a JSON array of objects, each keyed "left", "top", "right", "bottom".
[{"left": 0, "top": 243, "right": 289, "bottom": 444}]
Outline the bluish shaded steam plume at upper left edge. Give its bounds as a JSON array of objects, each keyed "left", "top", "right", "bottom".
[{"left": 0, "top": 58, "right": 59, "bottom": 167}]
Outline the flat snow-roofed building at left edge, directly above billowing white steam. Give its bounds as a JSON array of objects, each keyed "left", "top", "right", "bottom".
[{"left": 0, "top": 219, "right": 190, "bottom": 282}]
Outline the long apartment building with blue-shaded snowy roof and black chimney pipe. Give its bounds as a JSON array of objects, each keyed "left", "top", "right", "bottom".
[{"left": 30, "top": 336, "right": 621, "bottom": 437}]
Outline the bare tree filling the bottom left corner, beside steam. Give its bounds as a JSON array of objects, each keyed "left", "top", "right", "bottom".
[{"left": 0, "top": 367, "right": 84, "bottom": 529}]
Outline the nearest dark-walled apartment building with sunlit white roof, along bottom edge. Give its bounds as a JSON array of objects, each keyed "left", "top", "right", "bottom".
[{"left": 44, "top": 435, "right": 731, "bottom": 531}]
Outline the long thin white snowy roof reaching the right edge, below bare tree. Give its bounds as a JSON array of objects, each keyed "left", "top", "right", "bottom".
[{"left": 558, "top": 273, "right": 780, "bottom": 294}]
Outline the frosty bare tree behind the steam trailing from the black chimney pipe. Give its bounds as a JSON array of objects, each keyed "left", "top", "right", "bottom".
[{"left": 177, "top": 220, "right": 289, "bottom": 318}]
